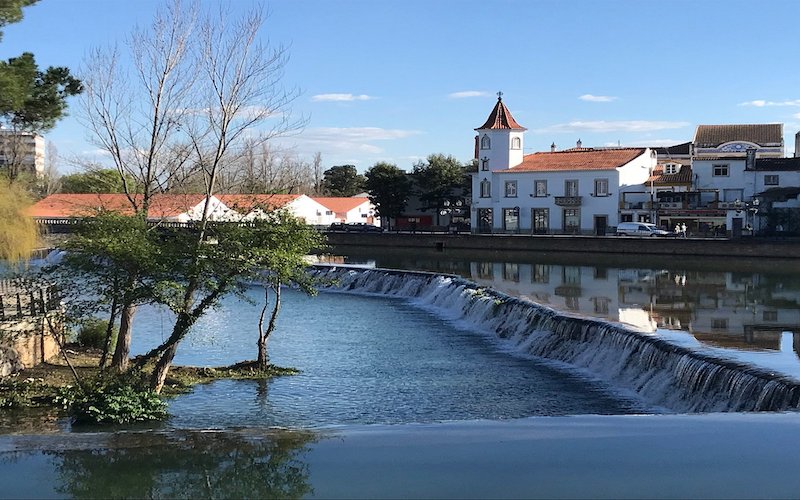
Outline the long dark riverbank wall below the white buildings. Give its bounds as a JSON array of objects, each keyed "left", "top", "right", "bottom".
[{"left": 327, "top": 233, "right": 800, "bottom": 259}]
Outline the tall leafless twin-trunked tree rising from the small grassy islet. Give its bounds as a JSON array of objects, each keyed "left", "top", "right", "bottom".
[{"left": 81, "top": 0, "right": 304, "bottom": 382}]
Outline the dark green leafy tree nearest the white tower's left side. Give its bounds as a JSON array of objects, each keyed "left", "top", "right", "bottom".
[{"left": 412, "top": 154, "right": 468, "bottom": 215}]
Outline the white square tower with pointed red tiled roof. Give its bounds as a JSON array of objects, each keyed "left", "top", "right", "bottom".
[{"left": 475, "top": 92, "right": 527, "bottom": 171}]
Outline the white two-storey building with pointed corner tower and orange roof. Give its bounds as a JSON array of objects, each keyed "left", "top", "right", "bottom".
[{"left": 471, "top": 95, "right": 656, "bottom": 234}]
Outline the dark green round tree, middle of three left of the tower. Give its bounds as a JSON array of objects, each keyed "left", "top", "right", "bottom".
[{"left": 365, "top": 162, "right": 411, "bottom": 229}]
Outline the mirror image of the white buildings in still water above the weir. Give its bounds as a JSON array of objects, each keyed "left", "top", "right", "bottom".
[{"left": 470, "top": 262, "right": 800, "bottom": 358}]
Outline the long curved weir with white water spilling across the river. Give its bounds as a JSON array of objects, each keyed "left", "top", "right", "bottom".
[{"left": 313, "top": 266, "right": 800, "bottom": 413}]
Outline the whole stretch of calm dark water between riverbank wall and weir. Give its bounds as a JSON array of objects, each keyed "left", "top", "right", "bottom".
[{"left": 330, "top": 251, "right": 800, "bottom": 374}]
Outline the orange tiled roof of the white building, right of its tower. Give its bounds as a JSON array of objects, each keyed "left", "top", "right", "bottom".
[{"left": 506, "top": 148, "right": 645, "bottom": 172}]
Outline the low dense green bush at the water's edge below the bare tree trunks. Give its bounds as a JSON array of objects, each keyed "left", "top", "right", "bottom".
[{"left": 56, "top": 376, "right": 167, "bottom": 424}]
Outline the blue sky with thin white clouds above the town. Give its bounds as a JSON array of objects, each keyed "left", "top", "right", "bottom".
[{"left": 0, "top": 0, "right": 800, "bottom": 173}]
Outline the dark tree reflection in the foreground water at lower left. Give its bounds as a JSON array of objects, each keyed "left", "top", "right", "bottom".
[{"left": 51, "top": 431, "right": 315, "bottom": 498}]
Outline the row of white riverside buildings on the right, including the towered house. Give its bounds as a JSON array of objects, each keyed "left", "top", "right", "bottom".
[{"left": 470, "top": 96, "right": 800, "bottom": 236}]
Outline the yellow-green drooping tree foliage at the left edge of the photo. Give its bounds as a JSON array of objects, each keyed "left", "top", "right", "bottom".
[{"left": 0, "top": 182, "right": 39, "bottom": 261}]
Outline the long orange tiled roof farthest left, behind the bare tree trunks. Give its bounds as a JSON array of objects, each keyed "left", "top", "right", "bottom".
[{"left": 30, "top": 194, "right": 205, "bottom": 219}]
